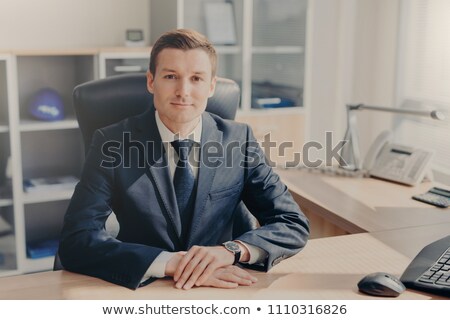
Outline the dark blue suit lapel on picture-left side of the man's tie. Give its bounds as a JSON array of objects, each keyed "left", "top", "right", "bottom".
[{"left": 136, "top": 108, "right": 181, "bottom": 243}]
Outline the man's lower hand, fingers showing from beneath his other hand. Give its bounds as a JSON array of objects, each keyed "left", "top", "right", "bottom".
[{"left": 203, "top": 266, "right": 258, "bottom": 289}]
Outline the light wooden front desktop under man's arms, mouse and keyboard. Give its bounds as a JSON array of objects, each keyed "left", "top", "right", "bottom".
[{"left": 0, "top": 223, "right": 450, "bottom": 300}]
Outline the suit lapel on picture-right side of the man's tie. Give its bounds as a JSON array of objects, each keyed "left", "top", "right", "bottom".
[{"left": 187, "top": 112, "right": 222, "bottom": 248}]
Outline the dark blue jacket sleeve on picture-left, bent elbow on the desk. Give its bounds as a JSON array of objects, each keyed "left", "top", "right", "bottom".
[{"left": 59, "top": 130, "right": 162, "bottom": 289}]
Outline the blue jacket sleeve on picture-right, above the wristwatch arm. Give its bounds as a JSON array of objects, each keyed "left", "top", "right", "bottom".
[{"left": 237, "top": 128, "right": 309, "bottom": 271}]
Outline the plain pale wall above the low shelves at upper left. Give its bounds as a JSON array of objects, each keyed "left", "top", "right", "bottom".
[{"left": 0, "top": 0, "right": 150, "bottom": 50}]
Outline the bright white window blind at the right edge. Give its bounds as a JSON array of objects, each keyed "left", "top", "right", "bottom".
[{"left": 395, "top": 0, "right": 450, "bottom": 173}]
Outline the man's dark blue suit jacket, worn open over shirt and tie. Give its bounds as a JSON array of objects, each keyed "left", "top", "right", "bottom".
[{"left": 59, "top": 111, "right": 309, "bottom": 288}]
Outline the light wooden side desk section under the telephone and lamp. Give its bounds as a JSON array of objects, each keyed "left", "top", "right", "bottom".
[{"left": 277, "top": 169, "right": 450, "bottom": 238}]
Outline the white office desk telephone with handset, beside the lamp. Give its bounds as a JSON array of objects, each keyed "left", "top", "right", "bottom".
[{"left": 363, "top": 131, "right": 434, "bottom": 186}]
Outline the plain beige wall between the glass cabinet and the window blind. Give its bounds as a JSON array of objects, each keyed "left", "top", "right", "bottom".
[{"left": 306, "top": 0, "right": 399, "bottom": 159}]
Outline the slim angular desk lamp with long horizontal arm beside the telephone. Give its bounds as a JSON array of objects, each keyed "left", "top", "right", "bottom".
[{"left": 340, "top": 104, "right": 445, "bottom": 171}]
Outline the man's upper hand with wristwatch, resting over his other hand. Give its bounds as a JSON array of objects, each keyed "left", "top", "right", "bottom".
[{"left": 173, "top": 246, "right": 250, "bottom": 289}]
